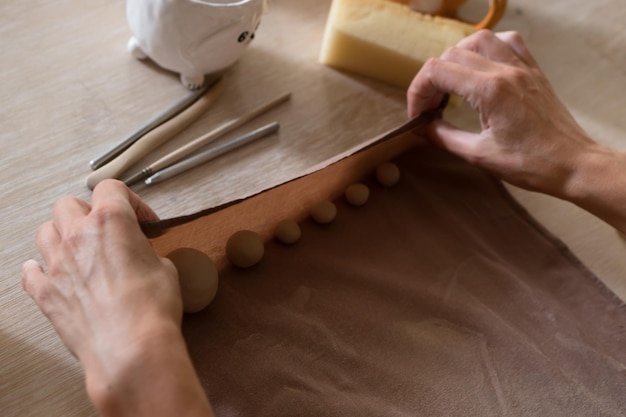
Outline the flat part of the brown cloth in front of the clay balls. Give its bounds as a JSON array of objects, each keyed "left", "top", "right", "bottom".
[{"left": 176, "top": 146, "right": 626, "bottom": 416}]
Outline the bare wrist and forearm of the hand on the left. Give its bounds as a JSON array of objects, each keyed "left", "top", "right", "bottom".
[{"left": 85, "top": 322, "right": 213, "bottom": 417}]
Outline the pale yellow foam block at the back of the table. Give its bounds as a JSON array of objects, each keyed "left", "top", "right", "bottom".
[{"left": 319, "top": 0, "right": 475, "bottom": 88}]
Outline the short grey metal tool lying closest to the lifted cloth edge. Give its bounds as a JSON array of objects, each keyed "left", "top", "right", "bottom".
[{"left": 145, "top": 122, "right": 279, "bottom": 185}]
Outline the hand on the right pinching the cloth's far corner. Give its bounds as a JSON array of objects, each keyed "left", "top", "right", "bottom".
[{"left": 407, "top": 30, "right": 599, "bottom": 198}]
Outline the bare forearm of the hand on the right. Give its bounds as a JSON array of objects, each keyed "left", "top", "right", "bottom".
[{"left": 557, "top": 144, "right": 626, "bottom": 233}]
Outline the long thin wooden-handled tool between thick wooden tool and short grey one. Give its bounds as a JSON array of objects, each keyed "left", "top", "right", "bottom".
[{"left": 124, "top": 93, "right": 291, "bottom": 185}]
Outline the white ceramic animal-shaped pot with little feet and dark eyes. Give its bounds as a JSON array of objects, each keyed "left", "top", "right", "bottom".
[{"left": 126, "top": 0, "right": 267, "bottom": 90}]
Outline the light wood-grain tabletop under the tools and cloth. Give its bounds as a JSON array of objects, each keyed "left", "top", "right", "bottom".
[{"left": 0, "top": 0, "right": 626, "bottom": 416}]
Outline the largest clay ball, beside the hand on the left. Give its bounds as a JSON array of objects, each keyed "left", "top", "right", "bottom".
[{"left": 167, "top": 248, "right": 218, "bottom": 313}]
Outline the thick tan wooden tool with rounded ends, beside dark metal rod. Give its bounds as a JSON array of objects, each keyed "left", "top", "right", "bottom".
[{"left": 85, "top": 77, "right": 224, "bottom": 189}]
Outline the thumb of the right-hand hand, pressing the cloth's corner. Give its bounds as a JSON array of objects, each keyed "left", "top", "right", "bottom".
[{"left": 425, "top": 119, "right": 480, "bottom": 160}]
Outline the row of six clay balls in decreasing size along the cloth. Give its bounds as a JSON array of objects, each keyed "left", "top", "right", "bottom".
[{"left": 167, "top": 163, "right": 400, "bottom": 313}]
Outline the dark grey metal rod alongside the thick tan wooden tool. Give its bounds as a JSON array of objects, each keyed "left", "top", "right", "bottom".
[{"left": 89, "top": 79, "right": 214, "bottom": 170}]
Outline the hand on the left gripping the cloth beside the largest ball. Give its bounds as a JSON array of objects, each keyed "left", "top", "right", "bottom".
[{"left": 22, "top": 180, "right": 184, "bottom": 412}]
